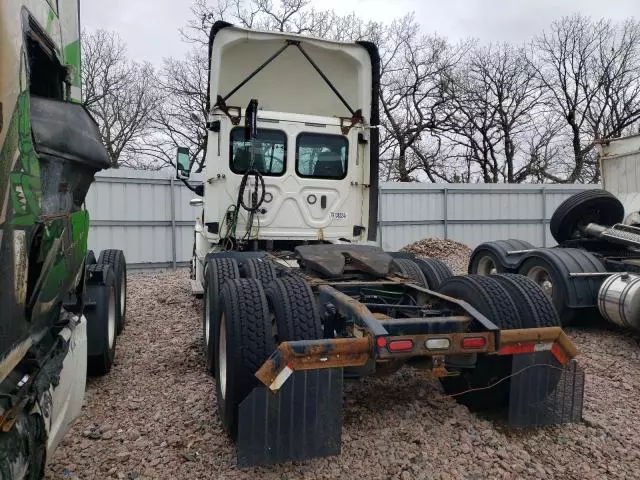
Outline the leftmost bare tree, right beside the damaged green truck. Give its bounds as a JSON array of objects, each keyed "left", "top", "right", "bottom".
[{"left": 82, "top": 30, "right": 159, "bottom": 168}]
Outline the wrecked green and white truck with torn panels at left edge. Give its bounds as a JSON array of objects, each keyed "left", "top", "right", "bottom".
[{"left": 0, "top": 0, "right": 126, "bottom": 479}]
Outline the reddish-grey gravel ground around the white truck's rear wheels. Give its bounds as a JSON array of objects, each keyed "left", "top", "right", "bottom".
[{"left": 47, "top": 273, "right": 640, "bottom": 480}]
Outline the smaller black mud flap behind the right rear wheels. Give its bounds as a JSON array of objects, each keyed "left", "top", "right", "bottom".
[{"left": 509, "top": 351, "right": 584, "bottom": 428}]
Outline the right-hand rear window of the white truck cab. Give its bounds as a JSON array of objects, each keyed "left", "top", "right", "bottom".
[{"left": 296, "top": 133, "right": 349, "bottom": 179}]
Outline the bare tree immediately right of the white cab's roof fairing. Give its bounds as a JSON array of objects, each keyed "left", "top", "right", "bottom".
[{"left": 380, "top": 15, "right": 465, "bottom": 182}]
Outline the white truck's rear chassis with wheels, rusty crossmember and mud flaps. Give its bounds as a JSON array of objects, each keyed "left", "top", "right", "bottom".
[{"left": 204, "top": 244, "right": 584, "bottom": 466}]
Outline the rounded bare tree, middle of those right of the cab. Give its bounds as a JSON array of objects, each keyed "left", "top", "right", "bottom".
[{"left": 437, "top": 44, "right": 542, "bottom": 183}]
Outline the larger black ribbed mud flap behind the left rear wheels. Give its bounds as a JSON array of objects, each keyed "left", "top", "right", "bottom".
[{"left": 237, "top": 368, "right": 343, "bottom": 467}]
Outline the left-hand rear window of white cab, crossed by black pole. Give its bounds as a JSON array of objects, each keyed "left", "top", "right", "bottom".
[{"left": 229, "top": 127, "right": 287, "bottom": 176}]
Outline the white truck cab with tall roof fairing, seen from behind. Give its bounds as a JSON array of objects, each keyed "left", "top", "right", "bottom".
[{"left": 178, "top": 22, "right": 379, "bottom": 284}]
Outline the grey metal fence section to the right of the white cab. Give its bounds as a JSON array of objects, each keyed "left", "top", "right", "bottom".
[{"left": 378, "top": 183, "right": 601, "bottom": 250}]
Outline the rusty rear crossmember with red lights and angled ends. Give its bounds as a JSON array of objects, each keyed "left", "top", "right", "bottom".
[{"left": 256, "top": 327, "right": 578, "bottom": 392}]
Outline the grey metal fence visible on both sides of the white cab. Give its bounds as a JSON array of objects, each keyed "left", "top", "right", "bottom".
[{"left": 87, "top": 168, "right": 600, "bottom": 269}]
